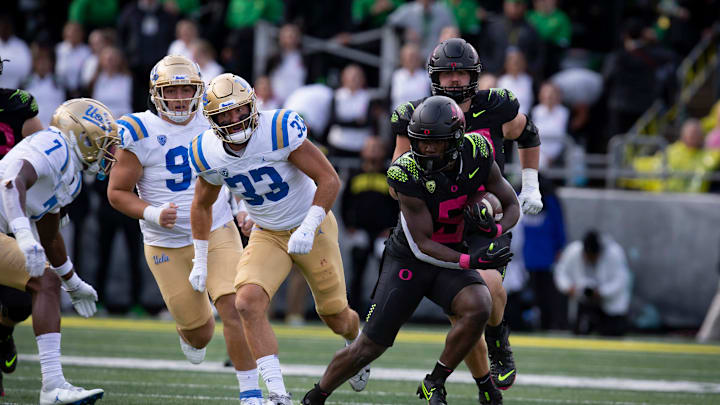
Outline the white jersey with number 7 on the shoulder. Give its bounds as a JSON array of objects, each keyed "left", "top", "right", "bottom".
[{"left": 0, "top": 127, "right": 82, "bottom": 233}]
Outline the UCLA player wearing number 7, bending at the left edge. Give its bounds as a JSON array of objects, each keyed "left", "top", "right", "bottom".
[{"left": 0, "top": 98, "right": 118, "bottom": 405}]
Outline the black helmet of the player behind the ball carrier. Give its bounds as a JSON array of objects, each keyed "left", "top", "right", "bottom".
[{"left": 428, "top": 38, "right": 482, "bottom": 104}]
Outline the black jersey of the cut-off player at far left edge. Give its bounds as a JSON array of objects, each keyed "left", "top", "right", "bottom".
[{"left": 0, "top": 89, "right": 38, "bottom": 159}]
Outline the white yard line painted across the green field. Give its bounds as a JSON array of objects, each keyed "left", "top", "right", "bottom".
[{"left": 18, "top": 354, "right": 720, "bottom": 394}]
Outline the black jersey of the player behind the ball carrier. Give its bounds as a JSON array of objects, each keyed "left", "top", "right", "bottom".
[{"left": 390, "top": 89, "right": 520, "bottom": 175}]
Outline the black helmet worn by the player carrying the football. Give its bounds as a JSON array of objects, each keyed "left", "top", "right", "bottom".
[{"left": 408, "top": 96, "right": 465, "bottom": 174}]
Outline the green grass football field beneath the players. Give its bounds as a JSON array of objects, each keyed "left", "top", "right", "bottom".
[{"left": 1, "top": 317, "right": 720, "bottom": 405}]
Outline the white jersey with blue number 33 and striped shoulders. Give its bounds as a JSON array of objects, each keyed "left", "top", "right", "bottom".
[{"left": 190, "top": 110, "right": 317, "bottom": 231}]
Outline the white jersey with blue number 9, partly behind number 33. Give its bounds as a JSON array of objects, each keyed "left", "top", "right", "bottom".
[{"left": 117, "top": 111, "right": 232, "bottom": 248}]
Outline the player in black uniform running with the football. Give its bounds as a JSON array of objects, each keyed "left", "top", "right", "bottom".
[{"left": 302, "top": 96, "right": 520, "bottom": 405}]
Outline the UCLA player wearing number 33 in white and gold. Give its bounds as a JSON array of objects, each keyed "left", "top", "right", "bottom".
[{"left": 189, "top": 74, "right": 370, "bottom": 404}]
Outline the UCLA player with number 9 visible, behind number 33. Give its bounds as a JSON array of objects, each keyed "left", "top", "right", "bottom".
[{"left": 108, "top": 55, "right": 259, "bottom": 404}]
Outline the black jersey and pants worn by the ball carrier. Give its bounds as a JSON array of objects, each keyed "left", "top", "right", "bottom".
[{"left": 363, "top": 134, "right": 493, "bottom": 347}]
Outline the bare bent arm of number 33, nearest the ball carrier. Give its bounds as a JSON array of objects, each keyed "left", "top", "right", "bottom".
[{"left": 288, "top": 140, "right": 340, "bottom": 212}]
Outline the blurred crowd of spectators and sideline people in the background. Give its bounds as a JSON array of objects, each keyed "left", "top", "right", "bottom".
[{"left": 0, "top": 0, "right": 720, "bottom": 333}]
